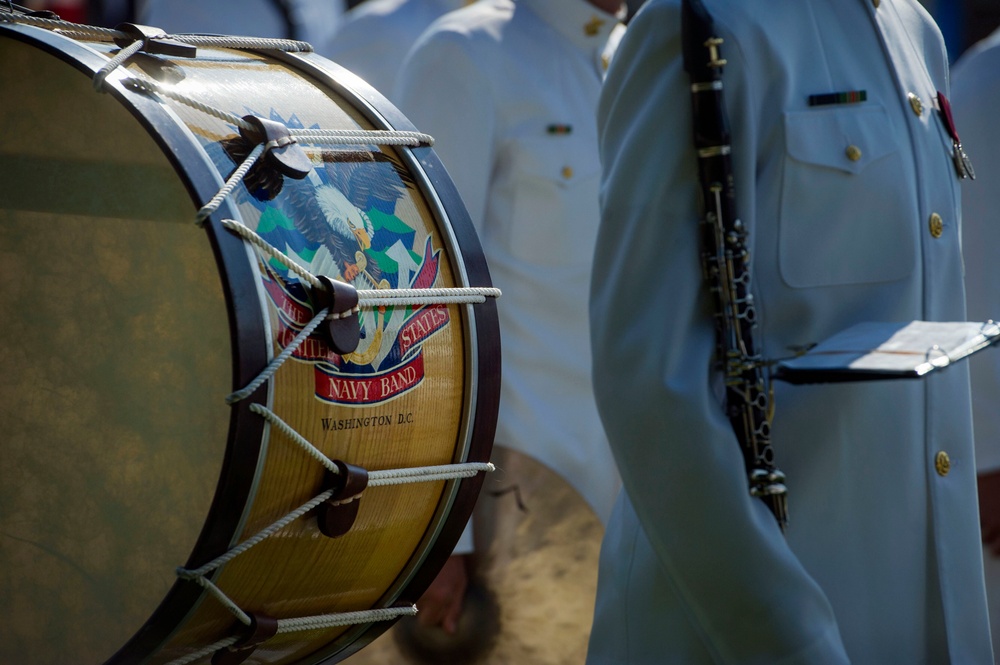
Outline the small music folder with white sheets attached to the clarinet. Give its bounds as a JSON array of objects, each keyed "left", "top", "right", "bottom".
[{"left": 771, "top": 320, "right": 1000, "bottom": 384}]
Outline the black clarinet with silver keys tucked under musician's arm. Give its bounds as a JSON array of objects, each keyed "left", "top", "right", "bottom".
[{"left": 681, "top": 0, "right": 788, "bottom": 530}]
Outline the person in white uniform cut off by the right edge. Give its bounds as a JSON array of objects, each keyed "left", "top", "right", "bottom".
[{"left": 952, "top": 24, "right": 1000, "bottom": 664}]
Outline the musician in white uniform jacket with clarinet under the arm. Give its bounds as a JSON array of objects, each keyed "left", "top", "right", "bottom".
[{"left": 587, "top": 0, "right": 993, "bottom": 665}]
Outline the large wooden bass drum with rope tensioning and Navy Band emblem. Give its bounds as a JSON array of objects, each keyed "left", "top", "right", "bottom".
[{"left": 0, "top": 9, "right": 499, "bottom": 665}]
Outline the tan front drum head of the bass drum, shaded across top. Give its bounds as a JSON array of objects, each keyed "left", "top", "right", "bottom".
[{"left": 0, "top": 32, "right": 231, "bottom": 663}]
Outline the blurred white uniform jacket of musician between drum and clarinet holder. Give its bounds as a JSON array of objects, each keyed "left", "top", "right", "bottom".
[{"left": 395, "top": 0, "right": 622, "bottom": 521}]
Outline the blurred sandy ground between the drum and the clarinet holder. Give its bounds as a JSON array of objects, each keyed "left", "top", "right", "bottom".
[{"left": 345, "top": 449, "right": 603, "bottom": 665}]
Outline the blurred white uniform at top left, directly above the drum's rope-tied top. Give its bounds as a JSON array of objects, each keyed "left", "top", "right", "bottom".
[{"left": 136, "top": 0, "right": 347, "bottom": 47}]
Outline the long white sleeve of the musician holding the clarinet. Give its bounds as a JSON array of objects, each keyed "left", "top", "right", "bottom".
[{"left": 590, "top": 4, "right": 860, "bottom": 664}]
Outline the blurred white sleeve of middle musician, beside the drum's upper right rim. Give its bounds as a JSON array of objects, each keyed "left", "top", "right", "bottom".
[{"left": 394, "top": 28, "right": 496, "bottom": 228}]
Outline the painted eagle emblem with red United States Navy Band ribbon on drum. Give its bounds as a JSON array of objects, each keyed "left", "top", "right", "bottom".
[{"left": 210, "top": 112, "right": 451, "bottom": 406}]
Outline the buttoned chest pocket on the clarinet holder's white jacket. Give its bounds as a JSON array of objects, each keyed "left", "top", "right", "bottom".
[{"left": 778, "top": 105, "right": 916, "bottom": 288}]
